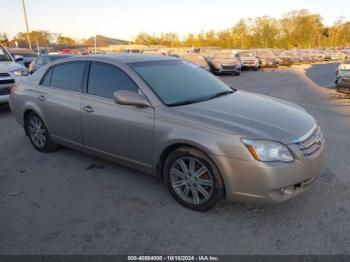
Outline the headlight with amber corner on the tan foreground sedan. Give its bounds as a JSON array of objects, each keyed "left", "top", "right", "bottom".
[{"left": 242, "top": 139, "right": 294, "bottom": 162}]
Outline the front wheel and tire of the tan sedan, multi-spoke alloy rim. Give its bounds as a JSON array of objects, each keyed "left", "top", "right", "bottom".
[{"left": 164, "top": 147, "right": 225, "bottom": 211}]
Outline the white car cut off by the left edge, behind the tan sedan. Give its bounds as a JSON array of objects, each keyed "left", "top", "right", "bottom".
[{"left": 0, "top": 45, "right": 28, "bottom": 103}]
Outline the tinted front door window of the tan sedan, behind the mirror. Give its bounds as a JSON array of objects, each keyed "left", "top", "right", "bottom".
[{"left": 88, "top": 63, "right": 138, "bottom": 98}]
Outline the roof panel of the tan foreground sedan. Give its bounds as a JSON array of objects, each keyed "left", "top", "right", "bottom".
[{"left": 65, "top": 54, "right": 178, "bottom": 64}]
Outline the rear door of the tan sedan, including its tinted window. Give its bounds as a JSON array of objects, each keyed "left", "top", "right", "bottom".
[{"left": 37, "top": 61, "right": 87, "bottom": 145}]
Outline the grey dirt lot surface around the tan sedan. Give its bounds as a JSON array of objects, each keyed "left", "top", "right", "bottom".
[{"left": 0, "top": 64, "right": 350, "bottom": 254}]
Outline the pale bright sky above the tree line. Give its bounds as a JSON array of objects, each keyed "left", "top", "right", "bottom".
[{"left": 0, "top": 0, "right": 350, "bottom": 40}]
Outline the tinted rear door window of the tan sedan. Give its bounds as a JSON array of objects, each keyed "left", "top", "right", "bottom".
[{"left": 50, "top": 62, "right": 85, "bottom": 92}]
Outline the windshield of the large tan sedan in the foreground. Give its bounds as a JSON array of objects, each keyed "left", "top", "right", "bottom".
[{"left": 130, "top": 60, "right": 233, "bottom": 106}]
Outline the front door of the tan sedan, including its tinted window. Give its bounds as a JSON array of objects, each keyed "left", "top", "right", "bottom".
[{"left": 81, "top": 62, "right": 154, "bottom": 167}]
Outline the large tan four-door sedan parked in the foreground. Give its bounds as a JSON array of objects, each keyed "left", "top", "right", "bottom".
[{"left": 10, "top": 55, "right": 324, "bottom": 211}]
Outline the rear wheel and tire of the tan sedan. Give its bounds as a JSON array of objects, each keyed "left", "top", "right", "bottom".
[{"left": 25, "top": 112, "right": 57, "bottom": 153}]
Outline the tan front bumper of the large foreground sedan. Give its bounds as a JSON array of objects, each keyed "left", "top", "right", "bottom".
[{"left": 217, "top": 140, "right": 325, "bottom": 204}]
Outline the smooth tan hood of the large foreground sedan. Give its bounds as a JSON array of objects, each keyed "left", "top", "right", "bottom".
[{"left": 174, "top": 91, "right": 316, "bottom": 144}]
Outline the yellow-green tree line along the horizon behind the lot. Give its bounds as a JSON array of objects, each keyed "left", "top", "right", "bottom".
[{"left": 0, "top": 10, "right": 350, "bottom": 49}]
